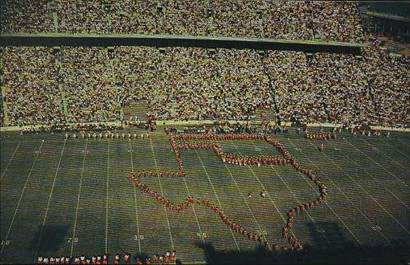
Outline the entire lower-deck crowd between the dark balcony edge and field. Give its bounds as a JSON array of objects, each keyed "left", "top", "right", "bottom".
[{"left": 2, "top": 44, "right": 410, "bottom": 127}]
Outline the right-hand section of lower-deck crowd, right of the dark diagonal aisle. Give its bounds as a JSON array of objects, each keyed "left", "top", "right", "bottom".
[{"left": 264, "top": 41, "right": 410, "bottom": 126}]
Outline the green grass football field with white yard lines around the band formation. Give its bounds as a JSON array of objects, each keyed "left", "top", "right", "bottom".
[{"left": 0, "top": 129, "right": 410, "bottom": 264}]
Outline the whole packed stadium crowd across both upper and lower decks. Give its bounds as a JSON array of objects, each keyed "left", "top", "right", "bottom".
[{"left": 2, "top": 0, "right": 410, "bottom": 127}]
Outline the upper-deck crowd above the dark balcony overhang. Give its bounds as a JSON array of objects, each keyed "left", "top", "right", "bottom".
[{"left": 1, "top": 0, "right": 364, "bottom": 42}]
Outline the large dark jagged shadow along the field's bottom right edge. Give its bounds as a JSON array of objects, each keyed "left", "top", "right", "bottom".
[{"left": 186, "top": 222, "right": 410, "bottom": 265}]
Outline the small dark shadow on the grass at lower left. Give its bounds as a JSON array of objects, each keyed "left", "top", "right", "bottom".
[{"left": 29, "top": 225, "right": 69, "bottom": 255}]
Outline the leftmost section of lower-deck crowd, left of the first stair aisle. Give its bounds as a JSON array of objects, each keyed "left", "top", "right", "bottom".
[{"left": 1, "top": 47, "right": 64, "bottom": 125}]
